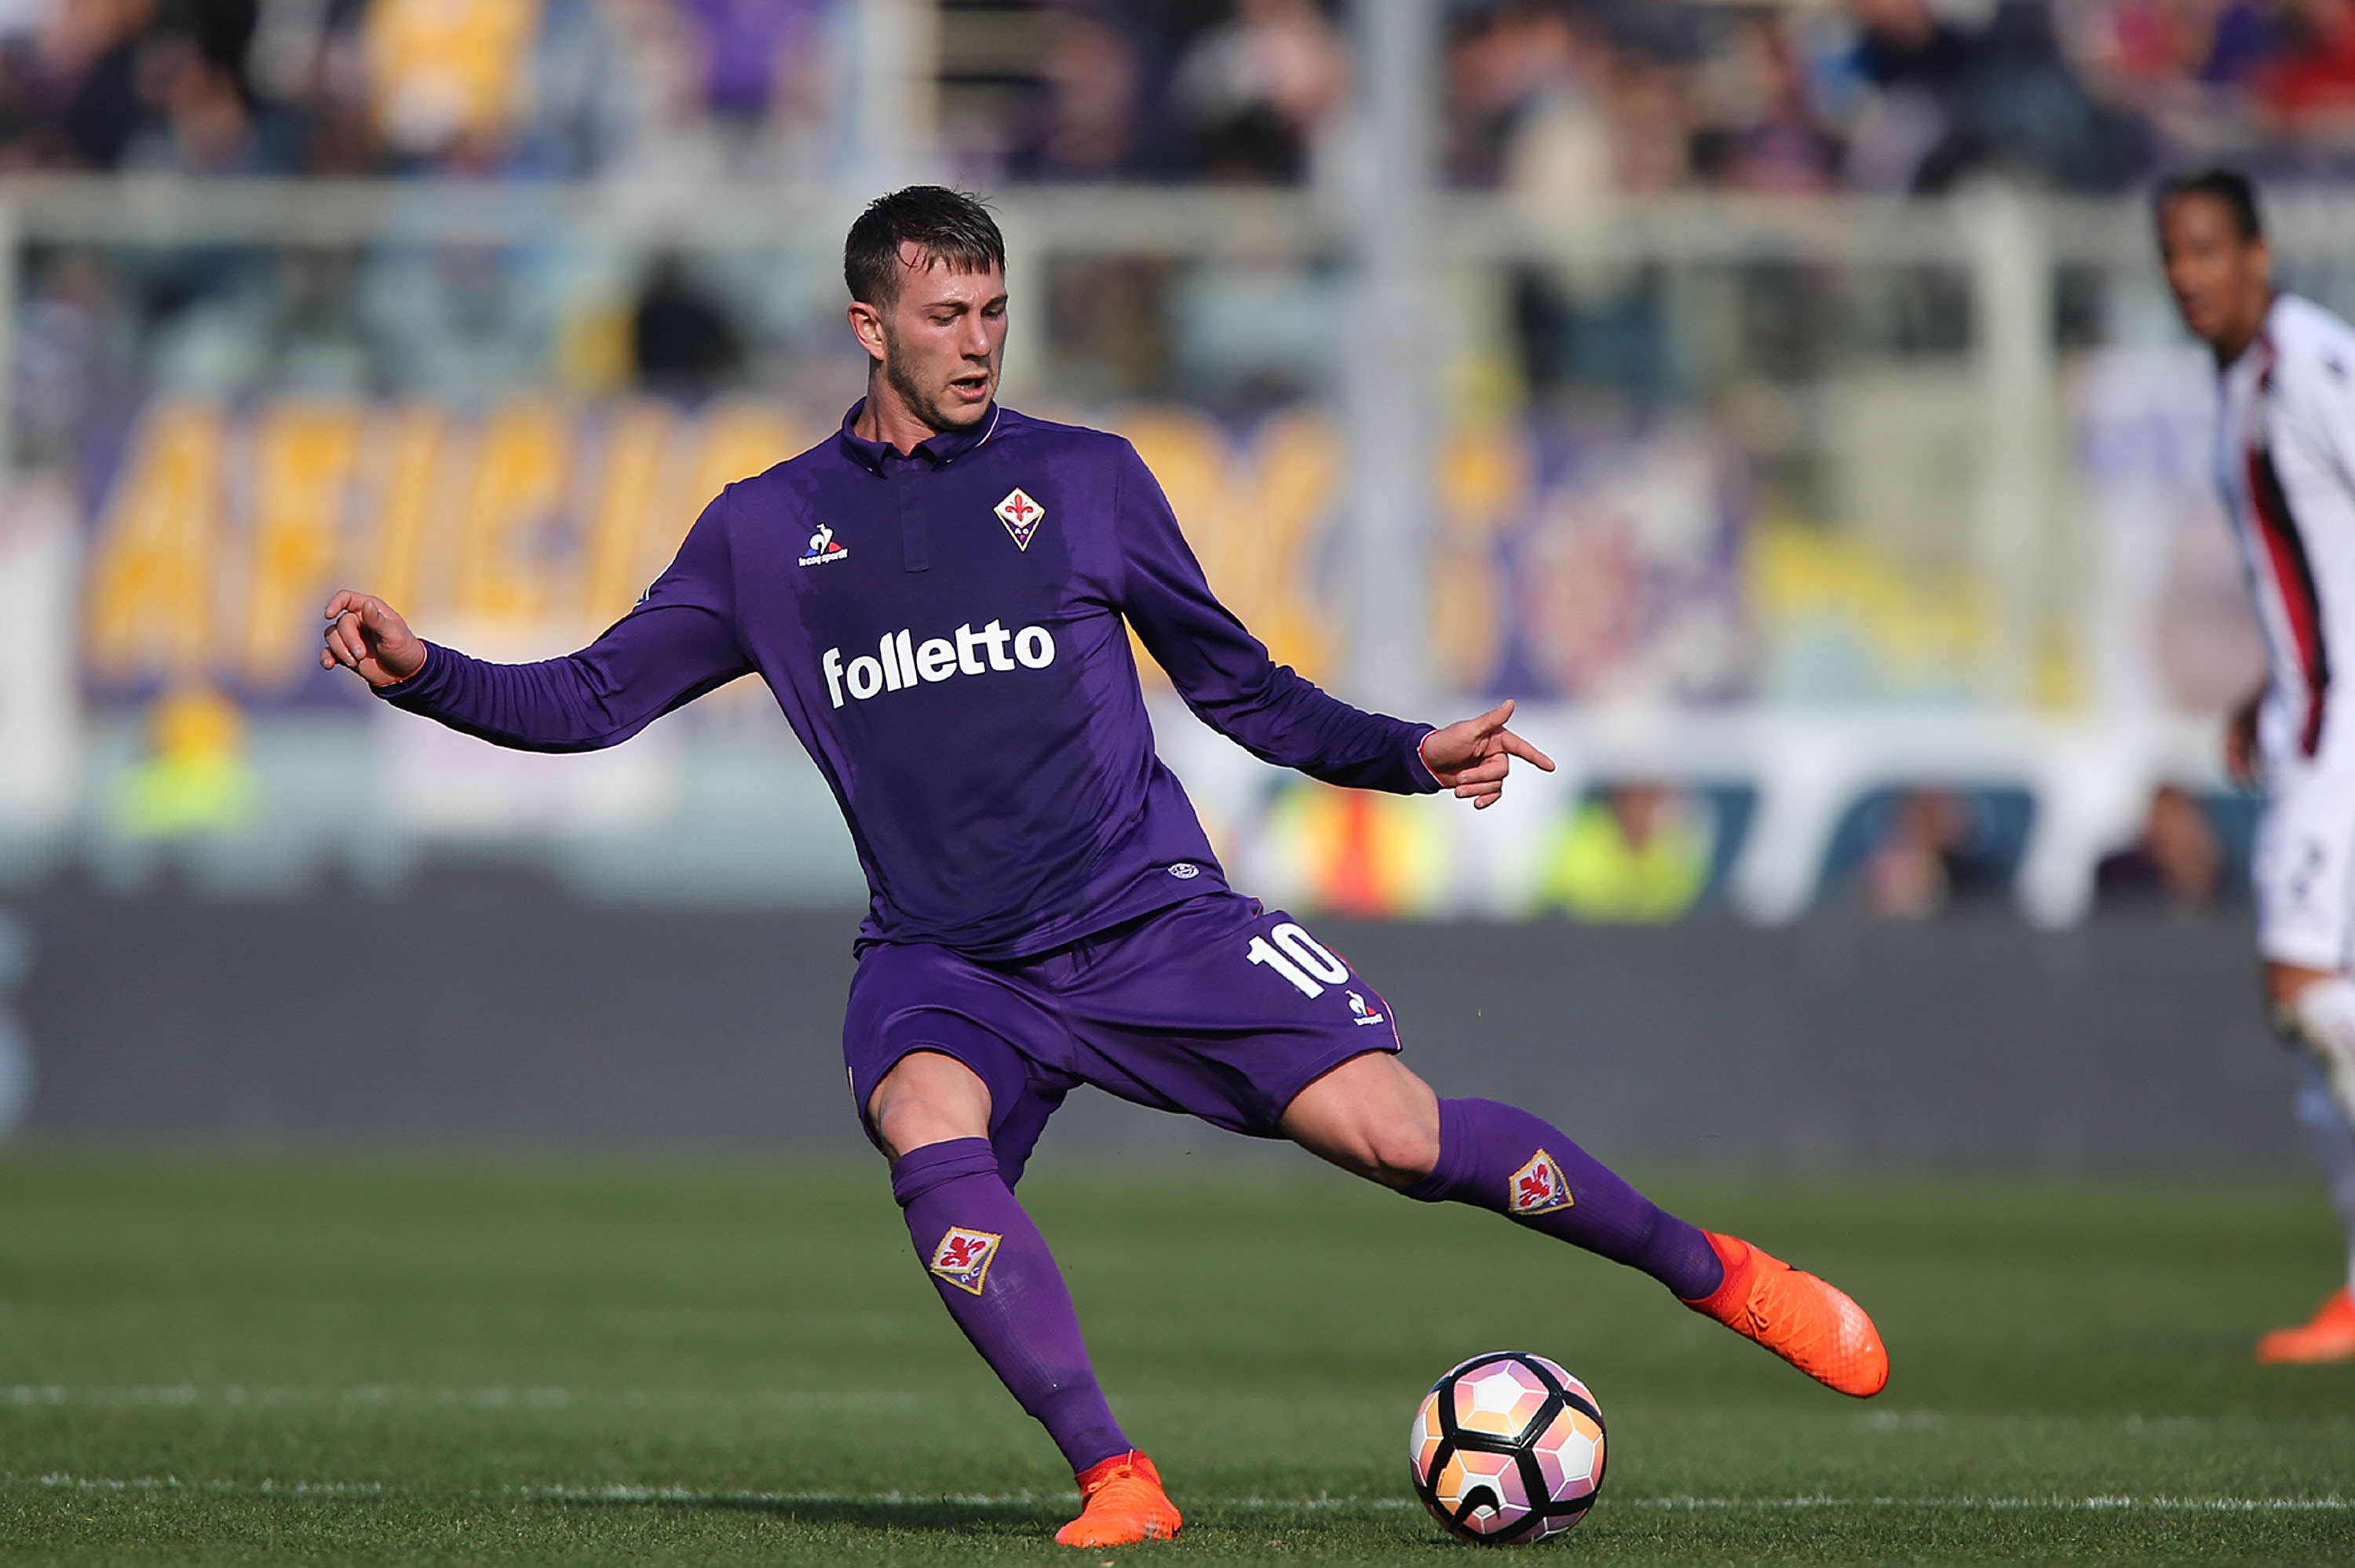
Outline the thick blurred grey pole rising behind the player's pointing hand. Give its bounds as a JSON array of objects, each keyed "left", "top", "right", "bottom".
[{"left": 1340, "top": 0, "right": 1439, "bottom": 713}]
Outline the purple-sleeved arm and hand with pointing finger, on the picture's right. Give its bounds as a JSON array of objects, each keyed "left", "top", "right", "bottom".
[{"left": 1114, "top": 450, "right": 1552, "bottom": 805}]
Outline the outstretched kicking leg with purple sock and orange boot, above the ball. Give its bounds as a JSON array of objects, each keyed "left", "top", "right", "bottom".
[{"left": 1281, "top": 1052, "right": 1889, "bottom": 1398}]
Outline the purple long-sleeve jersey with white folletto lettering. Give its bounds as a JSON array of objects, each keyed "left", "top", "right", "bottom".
[{"left": 377, "top": 405, "right": 1439, "bottom": 958}]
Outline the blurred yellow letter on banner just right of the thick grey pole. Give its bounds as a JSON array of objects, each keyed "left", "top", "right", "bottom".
[{"left": 1429, "top": 424, "right": 1531, "bottom": 690}]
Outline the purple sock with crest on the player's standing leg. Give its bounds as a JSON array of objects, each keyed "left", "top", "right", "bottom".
[{"left": 890, "top": 1137, "right": 1130, "bottom": 1474}]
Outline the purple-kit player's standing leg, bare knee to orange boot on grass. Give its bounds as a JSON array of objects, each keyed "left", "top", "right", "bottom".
[{"left": 869, "top": 1050, "right": 1182, "bottom": 1547}]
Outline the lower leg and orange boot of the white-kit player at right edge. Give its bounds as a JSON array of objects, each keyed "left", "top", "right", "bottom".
[{"left": 2256, "top": 963, "right": 2355, "bottom": 1363}]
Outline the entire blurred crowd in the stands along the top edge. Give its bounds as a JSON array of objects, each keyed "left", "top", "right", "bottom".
[{"left": 0, "top": 0, "right": 2355, "bottom": 198}]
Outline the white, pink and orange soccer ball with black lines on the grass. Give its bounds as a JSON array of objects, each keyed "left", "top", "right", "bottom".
[{"left": 1406, "top": 1351, "right": 1604, "bottom": 1547}]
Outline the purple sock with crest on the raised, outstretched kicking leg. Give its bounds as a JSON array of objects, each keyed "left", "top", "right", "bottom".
[{"left": 1406, "top": 1099, "right": 1726, "bottom": 1302}]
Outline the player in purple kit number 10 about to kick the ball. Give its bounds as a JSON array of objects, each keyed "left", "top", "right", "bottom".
[{"left": 320, "top": 186, "right": 1889, "bottom": 1547}]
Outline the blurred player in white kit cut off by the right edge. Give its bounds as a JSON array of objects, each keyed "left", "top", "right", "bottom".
[{"left": 2155, "top": 170, "right": 2355, "bottom": 1361}]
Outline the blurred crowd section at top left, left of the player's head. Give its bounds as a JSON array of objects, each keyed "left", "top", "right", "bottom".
[{"left": 0, "top": 0, "right": 843, "bottom": 179}]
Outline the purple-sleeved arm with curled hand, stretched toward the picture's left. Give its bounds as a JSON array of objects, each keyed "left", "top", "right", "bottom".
[{"left": 320, "top": 501, "right": 751, "bottom": 751}]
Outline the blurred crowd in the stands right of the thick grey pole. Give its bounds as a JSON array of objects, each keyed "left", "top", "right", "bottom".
[{"left": 1448, "top": 0, "right": 2355, "bottom": 195}]
